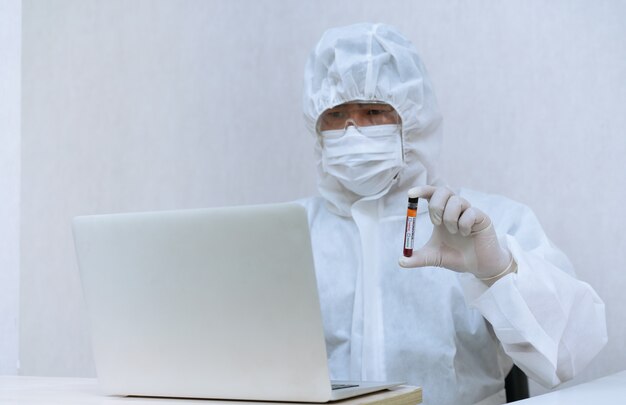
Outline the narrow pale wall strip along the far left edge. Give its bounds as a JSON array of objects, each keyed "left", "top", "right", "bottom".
[{"left": 0, "top": 0, "right": 22, "bottom": 375}]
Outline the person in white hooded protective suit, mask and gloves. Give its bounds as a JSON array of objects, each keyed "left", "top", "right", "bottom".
[{"left": 301, "top": 24, "right": 607, "bottom": 404}]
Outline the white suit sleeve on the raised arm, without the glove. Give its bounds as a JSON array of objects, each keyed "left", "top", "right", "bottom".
[{"left": 463, "top": 199, "right": 607, "bottom": 387}]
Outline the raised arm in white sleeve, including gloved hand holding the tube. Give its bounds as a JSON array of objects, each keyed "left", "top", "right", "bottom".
[{"left": 400, "top": 186, "right": 607, "bottom": 387}]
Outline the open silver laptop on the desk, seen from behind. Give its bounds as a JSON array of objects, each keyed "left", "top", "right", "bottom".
[{"left": 72, "top": 203, "right": 401, "bottom": 402}]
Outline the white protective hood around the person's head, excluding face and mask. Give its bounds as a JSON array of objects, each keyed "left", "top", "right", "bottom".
[{"left": 303, "top": 23, "right": 442, "bottom": 216}]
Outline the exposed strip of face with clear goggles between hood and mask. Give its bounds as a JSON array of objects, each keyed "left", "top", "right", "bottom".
[{"left": 317, "top": 101, "right": 401, "bottom": 132}]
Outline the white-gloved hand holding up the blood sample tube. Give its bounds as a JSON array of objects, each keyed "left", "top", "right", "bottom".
[{"left": 400, "top": 186, "right": 517, "bottom": 285}]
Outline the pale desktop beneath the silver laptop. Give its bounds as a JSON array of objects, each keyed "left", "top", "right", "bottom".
[{"left": 0, "top": 376, "right": 422, "bottom": 405}]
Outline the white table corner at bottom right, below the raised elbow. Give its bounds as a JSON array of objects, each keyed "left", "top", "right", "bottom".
[{"left": 515, "top": 371, "right": 626, "bottom": 405}]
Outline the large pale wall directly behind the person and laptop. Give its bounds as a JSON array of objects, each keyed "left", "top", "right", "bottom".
[{"left": 9, "top": 0, "right": 626, "bottom": 398}]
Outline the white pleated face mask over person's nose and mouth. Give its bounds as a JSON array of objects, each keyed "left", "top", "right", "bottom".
[{"left": 321, "top": 124, "right": 403, "bottom": 197}]
